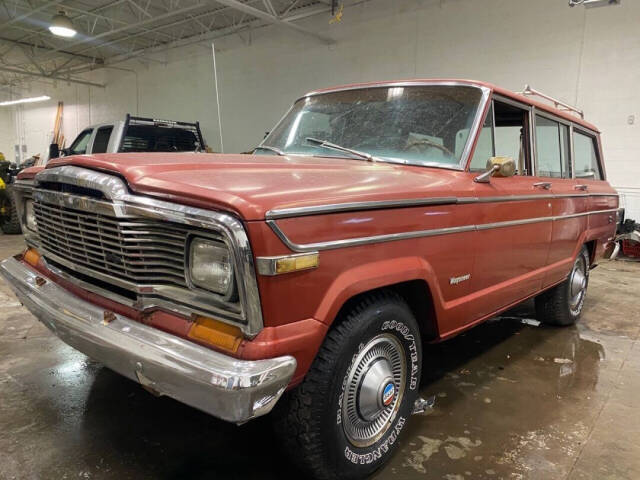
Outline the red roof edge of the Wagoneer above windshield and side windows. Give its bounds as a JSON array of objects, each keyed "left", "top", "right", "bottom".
[{"left": 303, "top": 78, "right": 600, "bottom": 133}]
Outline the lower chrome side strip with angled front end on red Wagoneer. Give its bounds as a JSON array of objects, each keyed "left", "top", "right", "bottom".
[{"left": 267, "top": 208, "right": 618, "bottom": 253}]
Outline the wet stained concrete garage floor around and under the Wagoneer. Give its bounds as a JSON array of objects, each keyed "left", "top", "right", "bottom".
[{"left": 0, "top": 232, "right": 640, "bottom": 480}]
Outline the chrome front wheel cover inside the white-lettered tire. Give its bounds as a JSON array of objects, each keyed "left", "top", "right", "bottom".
[{"left": 342, "top": 333, "right": 407, "bottom": 447}]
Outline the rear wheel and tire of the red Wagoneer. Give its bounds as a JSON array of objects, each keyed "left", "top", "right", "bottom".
[{"left": 535, "top": 246, "right": 590, "bottom": 326}]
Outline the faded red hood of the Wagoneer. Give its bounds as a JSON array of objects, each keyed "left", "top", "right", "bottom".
[{"left": 47, "top": 153, "right": 465, "bottom": 221}]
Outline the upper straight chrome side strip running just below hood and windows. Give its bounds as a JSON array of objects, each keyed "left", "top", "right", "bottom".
[{"left": 265, "top": 193, "right": 619, "bottom": 220}]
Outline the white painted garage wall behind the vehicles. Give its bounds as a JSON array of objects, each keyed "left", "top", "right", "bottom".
[{"left": 0, "top": 0, "right": 640, "bottom": 220}]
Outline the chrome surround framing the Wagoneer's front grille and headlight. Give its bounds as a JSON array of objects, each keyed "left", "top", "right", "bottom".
[{"left": 28, "top": 165, "right": 263, "bottom": 338}]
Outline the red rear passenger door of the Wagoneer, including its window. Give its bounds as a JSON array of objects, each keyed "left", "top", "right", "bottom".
[{"left": 535, "top": 111, "right": 589, "bottom": 287}]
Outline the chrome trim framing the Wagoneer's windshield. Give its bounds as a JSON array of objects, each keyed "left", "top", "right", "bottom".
[{"left": 260, "top": 80, "right": 491, "bottom": 171}]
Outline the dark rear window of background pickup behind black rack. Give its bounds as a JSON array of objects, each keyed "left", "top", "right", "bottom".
[{"left": 120, "top": 125, "right": 198, "bottom": 152}]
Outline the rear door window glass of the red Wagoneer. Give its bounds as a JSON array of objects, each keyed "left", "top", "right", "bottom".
[{"left": 536, "top": 115, "right": 571, "bottom": 178}]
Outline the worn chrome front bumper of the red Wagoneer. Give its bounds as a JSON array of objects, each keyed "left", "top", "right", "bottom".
[{"left": 0, "top": 258, "right": 296, "bottom": 423}]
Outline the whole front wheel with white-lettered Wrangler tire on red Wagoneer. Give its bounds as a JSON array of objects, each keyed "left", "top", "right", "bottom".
[{"left": 276, "top": 293, "right": 422, "bottom": 480}]
